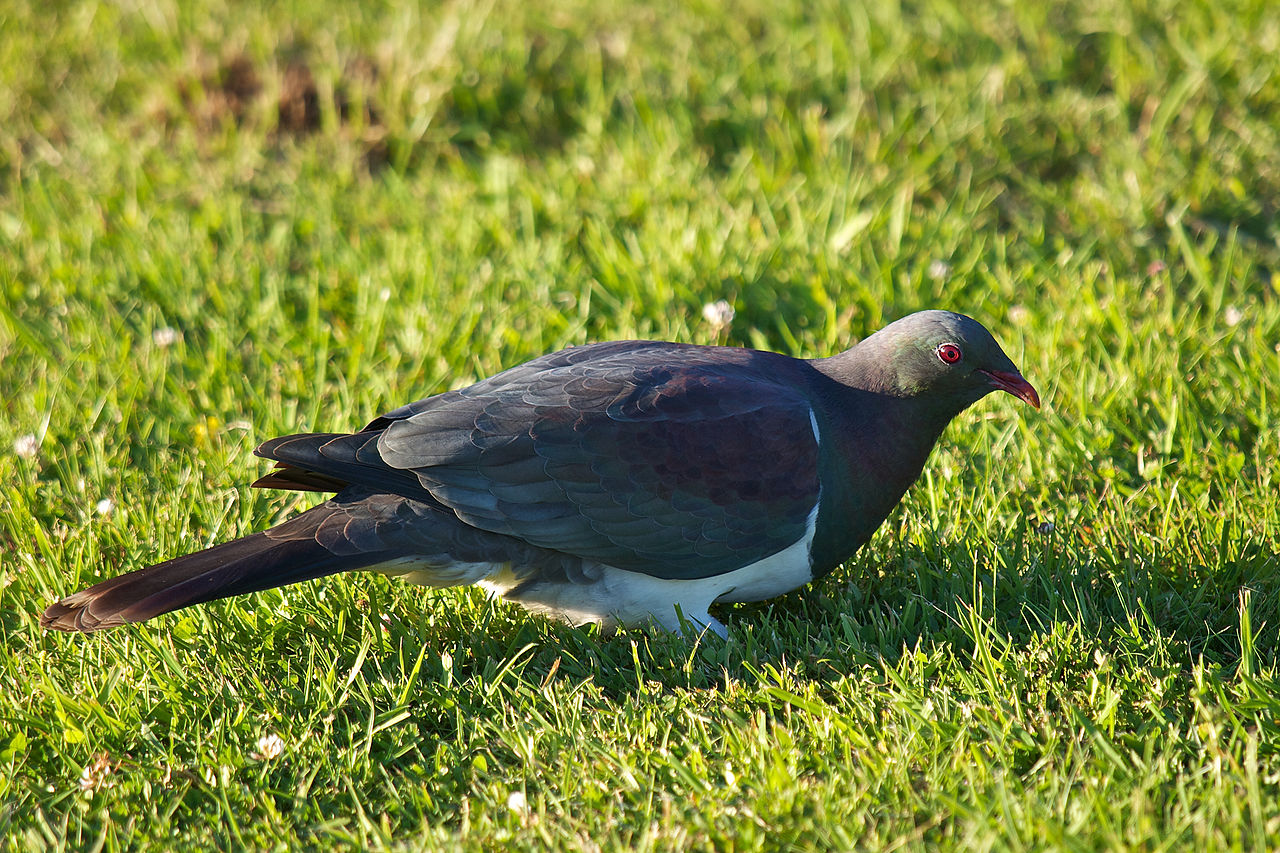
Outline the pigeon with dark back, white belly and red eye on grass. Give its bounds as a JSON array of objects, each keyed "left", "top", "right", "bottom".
[{"left": 41, "top": 310, "right": 1041, "bottom": 637}]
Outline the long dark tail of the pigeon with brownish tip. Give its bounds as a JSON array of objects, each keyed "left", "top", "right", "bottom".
[{"left": 40, "top": 506, "right": 394, "bottom": 633}]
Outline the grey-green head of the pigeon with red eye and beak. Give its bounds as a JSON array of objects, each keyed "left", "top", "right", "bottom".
[{"left": 846, "top": 311, "right": 1039, "bottom": 415}]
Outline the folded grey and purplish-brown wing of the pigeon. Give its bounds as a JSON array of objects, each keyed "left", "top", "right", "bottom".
[{"left": 264, "top": 342, "right": 818, "bottom": 579}]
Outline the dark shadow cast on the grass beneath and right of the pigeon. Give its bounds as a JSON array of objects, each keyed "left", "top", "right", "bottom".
[{"left": 389, "top": 528, "right": 1280, "bottom": 699}]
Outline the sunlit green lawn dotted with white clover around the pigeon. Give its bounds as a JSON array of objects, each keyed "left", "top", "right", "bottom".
[{"left": 0, "top": 0, "right": 1280, "bottom": 850}]
